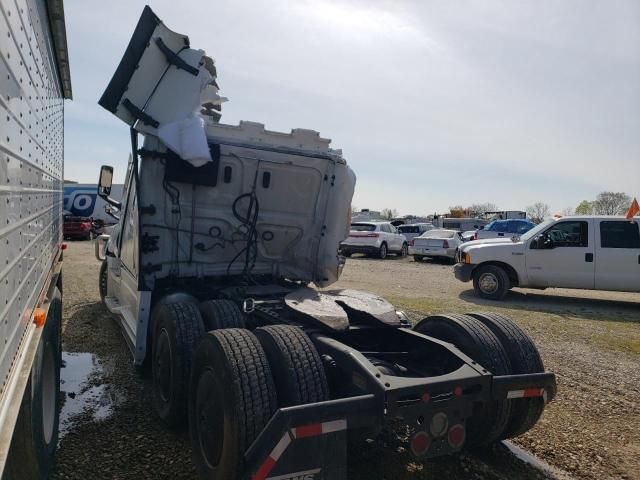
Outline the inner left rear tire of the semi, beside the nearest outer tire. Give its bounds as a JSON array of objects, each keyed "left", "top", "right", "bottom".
[{"left": 254, "top": 325, "right": 329, "bottom": 407}]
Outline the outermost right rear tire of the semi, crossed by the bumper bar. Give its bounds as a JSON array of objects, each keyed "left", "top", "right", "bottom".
[{"left": 468, "top": 312, "right": 544, "bottom": 438}]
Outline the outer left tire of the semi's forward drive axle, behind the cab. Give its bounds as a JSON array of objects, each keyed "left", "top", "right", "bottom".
[{"left": 151, "top": 302, "right": 205, "bottom": 429}]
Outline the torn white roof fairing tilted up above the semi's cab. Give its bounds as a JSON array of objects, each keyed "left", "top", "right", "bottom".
[{"left": 98, "top": 6, "right": 226, "bottom": 167}]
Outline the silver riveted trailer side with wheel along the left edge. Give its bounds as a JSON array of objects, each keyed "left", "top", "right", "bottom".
[{"left": 0, "top": 0, "right": 72, "bottom": 479}]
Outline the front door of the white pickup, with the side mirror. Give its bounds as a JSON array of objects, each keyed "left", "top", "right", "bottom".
[{"left": 525, "top": 220, "right": 595, "bottom": 289}]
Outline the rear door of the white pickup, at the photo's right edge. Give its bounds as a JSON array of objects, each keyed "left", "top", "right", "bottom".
[{"left": 596, "top": 220, "right": 640, "bottom": 292}]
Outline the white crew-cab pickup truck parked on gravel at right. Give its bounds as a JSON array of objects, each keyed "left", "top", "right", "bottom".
[{"left": 454, "top": 216, "right": 640, "bottom": 300}]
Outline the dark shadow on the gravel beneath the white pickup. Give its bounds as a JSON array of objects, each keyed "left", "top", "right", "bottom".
[{"left": 459, "top": 290, "right": 640, "bottom": 323}]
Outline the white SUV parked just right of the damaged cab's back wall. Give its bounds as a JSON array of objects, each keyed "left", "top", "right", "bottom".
[{"left": 340, "top": 222, "right": 409, "bottom": 259}]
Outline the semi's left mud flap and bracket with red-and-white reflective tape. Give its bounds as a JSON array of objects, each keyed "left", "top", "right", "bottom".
[{"left": 245, "top": 395, "right": 382, "bottom": 480}]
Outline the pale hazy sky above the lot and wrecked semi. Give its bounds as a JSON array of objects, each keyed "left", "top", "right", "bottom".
[{"left": 65, "top": 0, "right": 640, "bottom": 214}]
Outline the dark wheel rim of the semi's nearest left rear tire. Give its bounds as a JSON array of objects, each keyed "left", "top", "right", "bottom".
[{"left": 195, "top": 370, "right": 224, "bottom": 469}]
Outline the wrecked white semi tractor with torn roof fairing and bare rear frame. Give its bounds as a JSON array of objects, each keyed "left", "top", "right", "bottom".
[{"left": 96, "top": 7, "right": 556, "bottom": 480}]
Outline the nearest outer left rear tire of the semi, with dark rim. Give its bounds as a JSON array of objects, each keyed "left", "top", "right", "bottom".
[{"left": 189, "top": 329, "right": 278, "bottom": 480}]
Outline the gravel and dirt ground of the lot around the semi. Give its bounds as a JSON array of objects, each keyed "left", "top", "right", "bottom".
[{"left": 53, "top": 242, "right": 640, "bottom": 480}]
